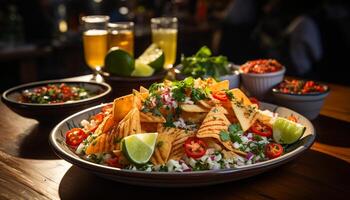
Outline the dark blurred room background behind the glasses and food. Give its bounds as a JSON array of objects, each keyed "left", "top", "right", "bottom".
[{"left": 0, "top": 0, "right": 350, "bottom": 92}]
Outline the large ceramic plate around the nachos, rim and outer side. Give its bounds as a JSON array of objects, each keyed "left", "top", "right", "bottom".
[{"left": 49, "top": 103, "right": 316, "bottom": 187}]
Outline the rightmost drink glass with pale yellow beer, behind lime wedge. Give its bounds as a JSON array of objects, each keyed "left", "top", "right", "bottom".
[{"left": 151, "top": 17, "right": 177, "bottom": 69}]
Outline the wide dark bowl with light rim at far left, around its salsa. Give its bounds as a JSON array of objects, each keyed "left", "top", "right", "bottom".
[{"left": 1, "top": 80, "right": 111, "bottom": 121}]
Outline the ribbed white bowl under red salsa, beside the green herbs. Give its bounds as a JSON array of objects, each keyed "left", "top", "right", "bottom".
[{"left": 240, "top": 66, "right": 286, "bottom": 99}]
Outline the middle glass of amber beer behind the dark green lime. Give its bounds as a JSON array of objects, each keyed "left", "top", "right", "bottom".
[{"left": 108, "top": 22, "right": 134, "bottom": 55}]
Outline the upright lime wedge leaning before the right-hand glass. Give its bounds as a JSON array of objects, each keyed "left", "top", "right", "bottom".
[{"left": 136, "top": 43, "right": 164, "bottom": 71}]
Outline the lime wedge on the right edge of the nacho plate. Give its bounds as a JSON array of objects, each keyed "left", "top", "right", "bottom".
[{"left": 272, "top": 117, "right": 306, "bottom": 144}]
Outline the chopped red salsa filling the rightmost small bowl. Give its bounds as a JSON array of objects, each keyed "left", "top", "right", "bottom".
[{"left": 276, "top": 79, "right": 327, "bottom": 94}]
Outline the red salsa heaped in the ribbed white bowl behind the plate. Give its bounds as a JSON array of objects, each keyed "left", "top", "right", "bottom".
[{"left": 241, "top": 59, "right": 282, "bottom": 74}]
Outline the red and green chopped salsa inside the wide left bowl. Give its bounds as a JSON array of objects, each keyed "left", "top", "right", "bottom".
[{"left": 20, "top": 83, "right": 92, "bottom": 104}]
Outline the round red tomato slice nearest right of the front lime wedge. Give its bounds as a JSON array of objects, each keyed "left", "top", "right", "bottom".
[{"left": 184, "top": 137, "right": 208, "bottom": 158}]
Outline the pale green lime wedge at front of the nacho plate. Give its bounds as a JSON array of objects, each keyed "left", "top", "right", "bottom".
[{"left": 122, "top": 133, "right": 158, "bottom": 165}]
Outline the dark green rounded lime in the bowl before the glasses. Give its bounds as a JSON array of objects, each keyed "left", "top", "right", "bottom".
[{"left": 105, "top": 48, "right": 135, "bottom": 76}]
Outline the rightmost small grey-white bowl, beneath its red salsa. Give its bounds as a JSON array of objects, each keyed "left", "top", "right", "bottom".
[{"left": 272, "top": 87, "right": 330, "bottom": 120}]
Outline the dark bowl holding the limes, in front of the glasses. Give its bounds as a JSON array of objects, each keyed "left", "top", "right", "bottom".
[{"left": 101, "top": 70, "right": 167, "bottom": 97}]
